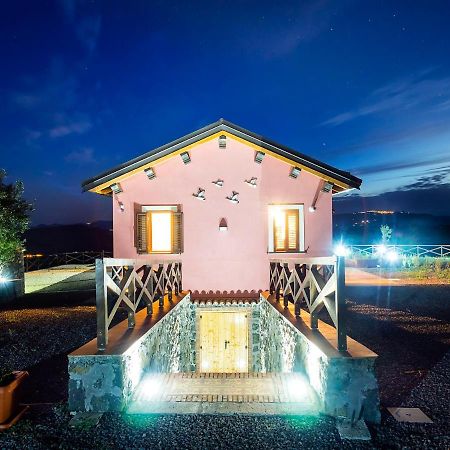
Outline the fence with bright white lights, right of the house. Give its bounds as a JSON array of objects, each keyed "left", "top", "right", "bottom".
[{"left": 348, "top": 244, "right": 450, "bottom": 257}]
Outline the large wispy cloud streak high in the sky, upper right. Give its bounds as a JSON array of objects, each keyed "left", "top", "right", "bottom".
[{"left": 322, "top": 69, "right": 450, "bottom": 126}]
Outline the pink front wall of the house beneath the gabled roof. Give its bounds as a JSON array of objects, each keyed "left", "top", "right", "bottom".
[{"left": 113, "top": 138, "right": 332, "bottom": 291}]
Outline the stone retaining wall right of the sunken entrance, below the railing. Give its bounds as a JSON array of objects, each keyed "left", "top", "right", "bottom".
[{"left": 259, "top": 297, "right": 380, "bottom": 423}]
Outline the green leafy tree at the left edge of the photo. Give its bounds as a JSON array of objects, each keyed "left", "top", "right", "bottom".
[{"left": 0, "top": 169, "right": 33, "bottom": 275}]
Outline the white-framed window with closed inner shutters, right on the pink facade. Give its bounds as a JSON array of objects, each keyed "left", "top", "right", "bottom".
[{"left": 268, "top": 205, "right": 304, "bottom": 253}]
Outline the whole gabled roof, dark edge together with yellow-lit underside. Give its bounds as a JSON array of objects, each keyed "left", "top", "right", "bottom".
[{"left": 82, "top": 119, "right": 362, "bottom": 194}]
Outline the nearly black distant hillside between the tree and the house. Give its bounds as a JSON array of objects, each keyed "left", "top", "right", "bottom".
[{"left": 25, "top": 221, "right": 112, "bottom": 254}]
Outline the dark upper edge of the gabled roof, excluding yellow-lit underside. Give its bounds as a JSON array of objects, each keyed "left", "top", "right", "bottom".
[{"left": 81, "top": 119, "right": 362, "bottom": 191}]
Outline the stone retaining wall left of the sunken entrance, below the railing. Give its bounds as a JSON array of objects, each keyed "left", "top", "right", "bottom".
[{"left": 69, "top": 294, "right": 196, "bottom": 411}]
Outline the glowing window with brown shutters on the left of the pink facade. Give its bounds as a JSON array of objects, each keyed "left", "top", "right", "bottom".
[{"left": 136, "top": 206, "right": 182, "bottom": 254}]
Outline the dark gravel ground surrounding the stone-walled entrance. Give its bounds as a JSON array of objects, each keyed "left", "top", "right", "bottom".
[{"left": 0, "top": 286, "right": 450, "bottom": 449}]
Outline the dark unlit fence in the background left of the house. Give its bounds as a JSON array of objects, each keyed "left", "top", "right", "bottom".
[{"left": 24, "top": 251, "right": 111, "bottom": 272}]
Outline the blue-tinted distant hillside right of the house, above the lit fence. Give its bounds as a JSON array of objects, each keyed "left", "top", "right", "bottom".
[{"left": 333, "top": 211, "right": 450, "bottom": 244}]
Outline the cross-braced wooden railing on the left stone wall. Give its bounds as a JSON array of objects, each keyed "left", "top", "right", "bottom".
[{"left": 95, "top": 258, "right": 182, "bottom": 350}]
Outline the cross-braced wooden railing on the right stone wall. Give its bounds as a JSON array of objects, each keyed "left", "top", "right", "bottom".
[{"left": 270, "top": 256, "right": 347, "bottom": 351}]
